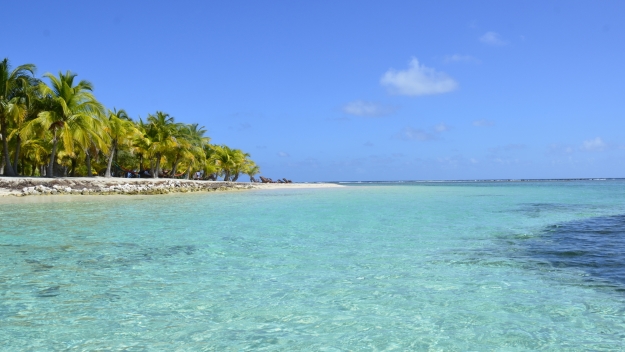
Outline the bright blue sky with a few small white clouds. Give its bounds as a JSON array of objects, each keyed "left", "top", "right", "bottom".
[{"left": 0, "top": 0, "right": 625, "bottom": 182}]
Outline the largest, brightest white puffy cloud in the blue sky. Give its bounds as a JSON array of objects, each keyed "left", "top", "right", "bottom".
[{"left": 380, "top": 58, "right": 458, "bottom": 96}]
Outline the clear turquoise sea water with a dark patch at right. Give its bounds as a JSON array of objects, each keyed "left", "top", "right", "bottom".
[{"left": 0, "top": 181, "right": 625, "bottom": 351}]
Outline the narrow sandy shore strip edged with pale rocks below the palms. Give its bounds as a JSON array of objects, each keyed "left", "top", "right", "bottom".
[{"left": 0, "top": 177, "right": 345, "bottom": 198}]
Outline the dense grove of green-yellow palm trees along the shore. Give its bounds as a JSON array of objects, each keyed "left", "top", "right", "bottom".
[{"left": 0, "top": 59, "right": 260, "bottom": 181}]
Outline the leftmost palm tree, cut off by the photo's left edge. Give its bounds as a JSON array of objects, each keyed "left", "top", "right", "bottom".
[{"left": 0, "top": 58, "right": 35, "bottom": 176}]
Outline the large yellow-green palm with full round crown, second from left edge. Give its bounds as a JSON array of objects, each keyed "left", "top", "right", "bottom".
[{"left": 25, "top": 71, "right": 104, "bottom": 177}]
